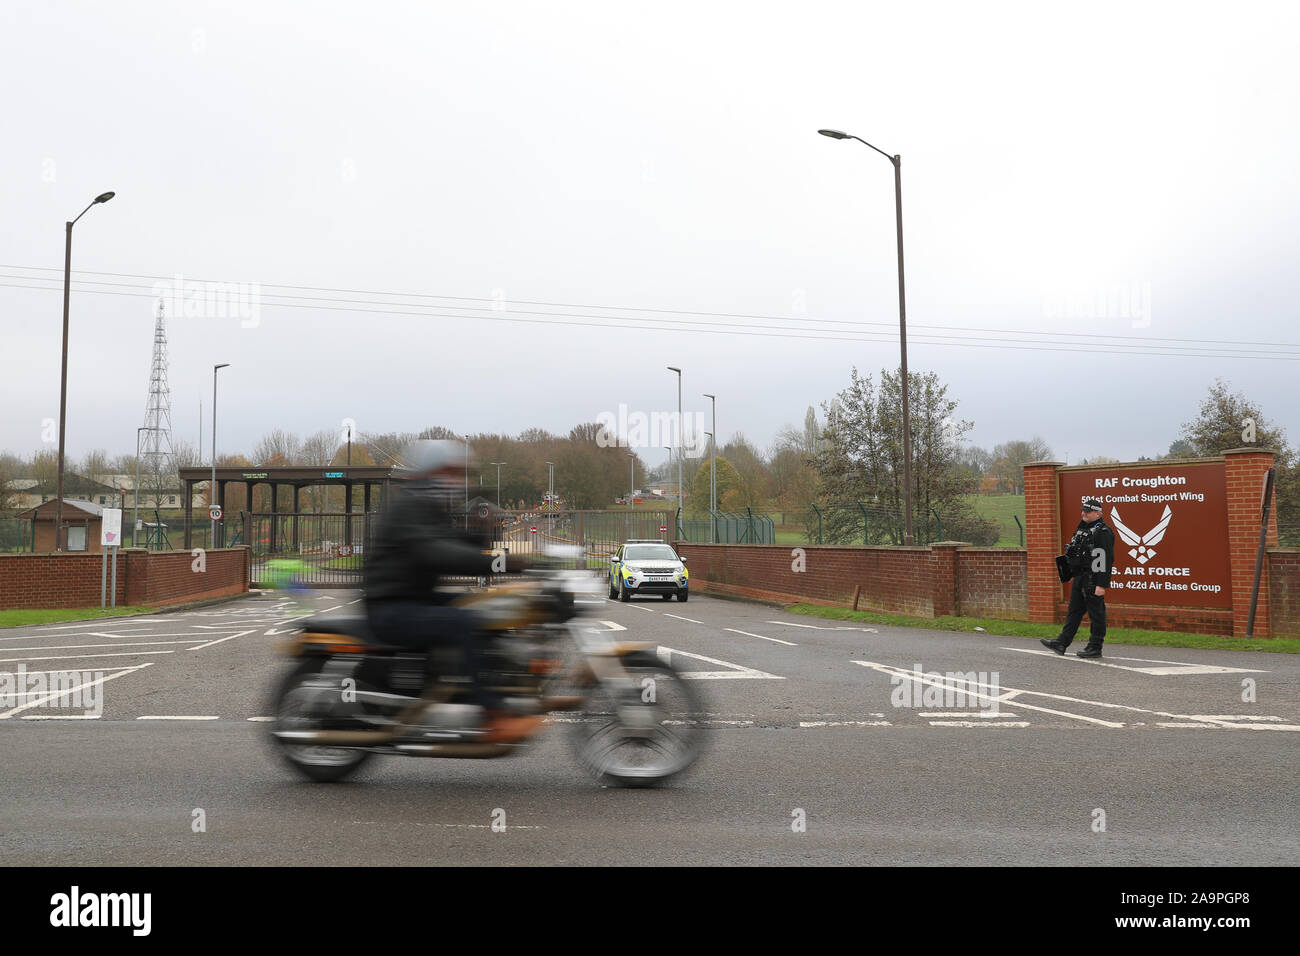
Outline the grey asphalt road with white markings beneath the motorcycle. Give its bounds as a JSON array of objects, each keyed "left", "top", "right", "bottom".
[{"left": 0, "top": 591, "right": 1300, "bottom": 866}]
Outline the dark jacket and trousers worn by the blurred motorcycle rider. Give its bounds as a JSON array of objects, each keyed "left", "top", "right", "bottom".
[{"left": 364, "top": 488, "right": 497, "bottom": 708}]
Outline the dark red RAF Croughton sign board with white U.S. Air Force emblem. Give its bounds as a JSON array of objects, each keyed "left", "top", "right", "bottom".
[{"left": 1058, "top": 462, "right": 1232, "bottom": 607}]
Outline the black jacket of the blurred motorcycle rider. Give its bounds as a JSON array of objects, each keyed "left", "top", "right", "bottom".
[{"left": 365, "top": 488, "right": 493, "bottom": 602}]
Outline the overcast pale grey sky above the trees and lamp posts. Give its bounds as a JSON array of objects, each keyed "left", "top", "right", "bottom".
[{"left": 0, "top": 0, "right": 1300, "bottom": 462}]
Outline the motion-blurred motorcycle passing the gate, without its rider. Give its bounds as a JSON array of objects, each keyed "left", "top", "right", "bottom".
[{"left": 269, "top": 548, "right": 703, "bottom": 787}]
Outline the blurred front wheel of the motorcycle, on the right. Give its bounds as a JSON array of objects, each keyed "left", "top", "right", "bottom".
[{"left": 571, "top": 652, "right": 705, "bottom": 787}]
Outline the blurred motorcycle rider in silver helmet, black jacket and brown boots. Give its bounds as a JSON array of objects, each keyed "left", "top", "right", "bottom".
[{"left": 364, "top": 440, "right": 543, "bottom": 743}]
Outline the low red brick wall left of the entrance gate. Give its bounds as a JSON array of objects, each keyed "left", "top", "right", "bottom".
[{"left": 0, "top": 548, "right": 251, "bottom": 609}]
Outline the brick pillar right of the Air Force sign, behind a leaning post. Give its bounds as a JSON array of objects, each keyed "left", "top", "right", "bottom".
[{"left": 1223, "top": 449, "right": 1278, "bottom": 637}]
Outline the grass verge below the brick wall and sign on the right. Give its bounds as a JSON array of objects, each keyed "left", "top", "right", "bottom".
[{"left": 785, "top": 604, "right": 1300, "bottom": 654}]
